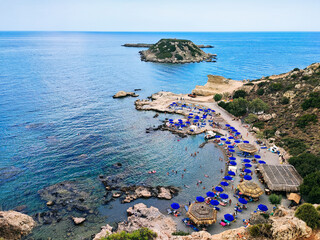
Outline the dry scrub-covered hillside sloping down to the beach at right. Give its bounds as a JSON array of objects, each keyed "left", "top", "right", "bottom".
[{"left": 247, "top": 63, "right": 320, "bottom": 155}]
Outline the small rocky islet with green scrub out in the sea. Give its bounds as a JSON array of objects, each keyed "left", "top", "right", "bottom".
[{"left": 140, "top": 39, "right": 214, "bottom": 63}]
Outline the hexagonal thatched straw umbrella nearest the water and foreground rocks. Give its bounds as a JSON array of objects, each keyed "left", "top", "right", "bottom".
[{"left": 187, "top": 202, "right": 217, "bottom": 225}]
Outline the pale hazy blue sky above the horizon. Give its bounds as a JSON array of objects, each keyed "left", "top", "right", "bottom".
[{"left": 0, "top": 0, "right": 320, "bottom": 32}]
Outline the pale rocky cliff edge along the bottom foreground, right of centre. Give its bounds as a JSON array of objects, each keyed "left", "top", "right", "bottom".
[{"left": 94, "top": 203, "right": 320, "bottom": 240}]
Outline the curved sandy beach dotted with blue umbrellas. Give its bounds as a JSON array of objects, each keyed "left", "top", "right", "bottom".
[{"left": 136, "top": 92, "right": 290, "bottom": 234}]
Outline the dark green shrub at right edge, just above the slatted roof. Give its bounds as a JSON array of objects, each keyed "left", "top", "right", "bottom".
[{"left": 289, "top": 153, "right": 320, "bottom": 177}]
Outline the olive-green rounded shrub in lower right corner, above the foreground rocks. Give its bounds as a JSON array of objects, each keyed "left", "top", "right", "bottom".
[{"left": 294, "top": 203, "right": 320, "bottom": 229}]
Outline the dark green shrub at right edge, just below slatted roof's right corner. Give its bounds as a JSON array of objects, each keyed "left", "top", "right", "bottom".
[{"left": 300, "top": 171, "right": 320, "bottom": 203}]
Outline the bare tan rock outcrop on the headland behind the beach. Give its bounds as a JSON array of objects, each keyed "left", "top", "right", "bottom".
[{"left": 192, "top": 75, "right": 243, "bottom": 96}]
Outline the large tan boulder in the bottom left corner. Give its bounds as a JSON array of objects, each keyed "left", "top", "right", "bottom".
[{"left": 0, "top": 211, "right": 36, "bottom": 240}]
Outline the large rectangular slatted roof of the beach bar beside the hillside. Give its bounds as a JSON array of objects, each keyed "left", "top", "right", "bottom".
[{"left": 259, "top": 164, "right": 303, "bottom": 193}]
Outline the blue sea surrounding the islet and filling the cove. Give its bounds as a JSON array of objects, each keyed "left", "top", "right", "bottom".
[{"left": 0, "top": 32, "right": 320, "bottom": 239}]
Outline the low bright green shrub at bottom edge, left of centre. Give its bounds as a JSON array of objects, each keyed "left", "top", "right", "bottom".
[{"left": 102, "top": 228, "right": 157, "bottom": 240}]
